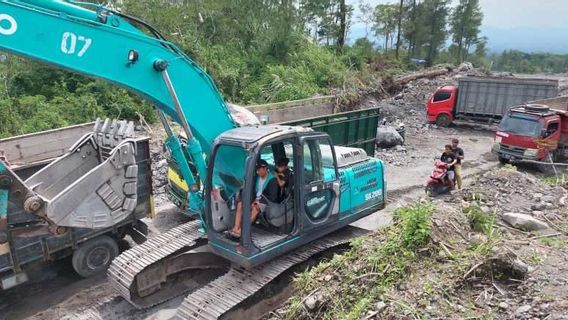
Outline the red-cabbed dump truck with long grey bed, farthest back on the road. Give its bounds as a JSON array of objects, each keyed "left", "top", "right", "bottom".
[{"left": 426, "top": 77, "right": 558, "bottom": 127}]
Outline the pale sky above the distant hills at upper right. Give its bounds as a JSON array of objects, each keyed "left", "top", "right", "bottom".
[{"left": 347, "top": 0, "right": 568, "bottom": 29}]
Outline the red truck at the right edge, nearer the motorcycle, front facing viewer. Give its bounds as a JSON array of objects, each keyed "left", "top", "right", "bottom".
[{"left": 492, "top": 96, "right": 568, "bottom": 170}]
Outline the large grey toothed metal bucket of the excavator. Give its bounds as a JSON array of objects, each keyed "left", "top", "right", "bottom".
[{"left": 24, "top": 119, "right": 142, "bottom": 229}]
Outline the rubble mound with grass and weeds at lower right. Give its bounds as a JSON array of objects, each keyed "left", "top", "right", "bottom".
[{"left": 276, "top": 167, "right": 568, "bottom": 319}]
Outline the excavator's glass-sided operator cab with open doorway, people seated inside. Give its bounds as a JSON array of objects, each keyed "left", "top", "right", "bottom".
[{"left": 205, "top": 126, "right": 340, "bottom": 267}]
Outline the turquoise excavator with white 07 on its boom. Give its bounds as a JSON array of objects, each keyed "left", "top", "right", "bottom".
[{"left": 0, "top": 0, "right": 386, "bottom": 319}]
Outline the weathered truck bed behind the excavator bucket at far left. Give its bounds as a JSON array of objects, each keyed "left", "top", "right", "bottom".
[{"left": 0, "top": 124, "right": 153, "bottom": 289}]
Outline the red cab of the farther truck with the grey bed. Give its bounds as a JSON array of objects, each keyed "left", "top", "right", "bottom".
[{"left": 426, "top": 86, "right": 458, "bottom": 127}]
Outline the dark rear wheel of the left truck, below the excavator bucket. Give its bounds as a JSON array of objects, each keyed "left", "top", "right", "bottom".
[{"left": 72, "top": 236, "right": 118, "bottom": 278}]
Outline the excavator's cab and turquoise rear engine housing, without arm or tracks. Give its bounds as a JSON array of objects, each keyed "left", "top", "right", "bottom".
[{"left": 205, "top": 126, "right": 385, "bottom": 267}]
